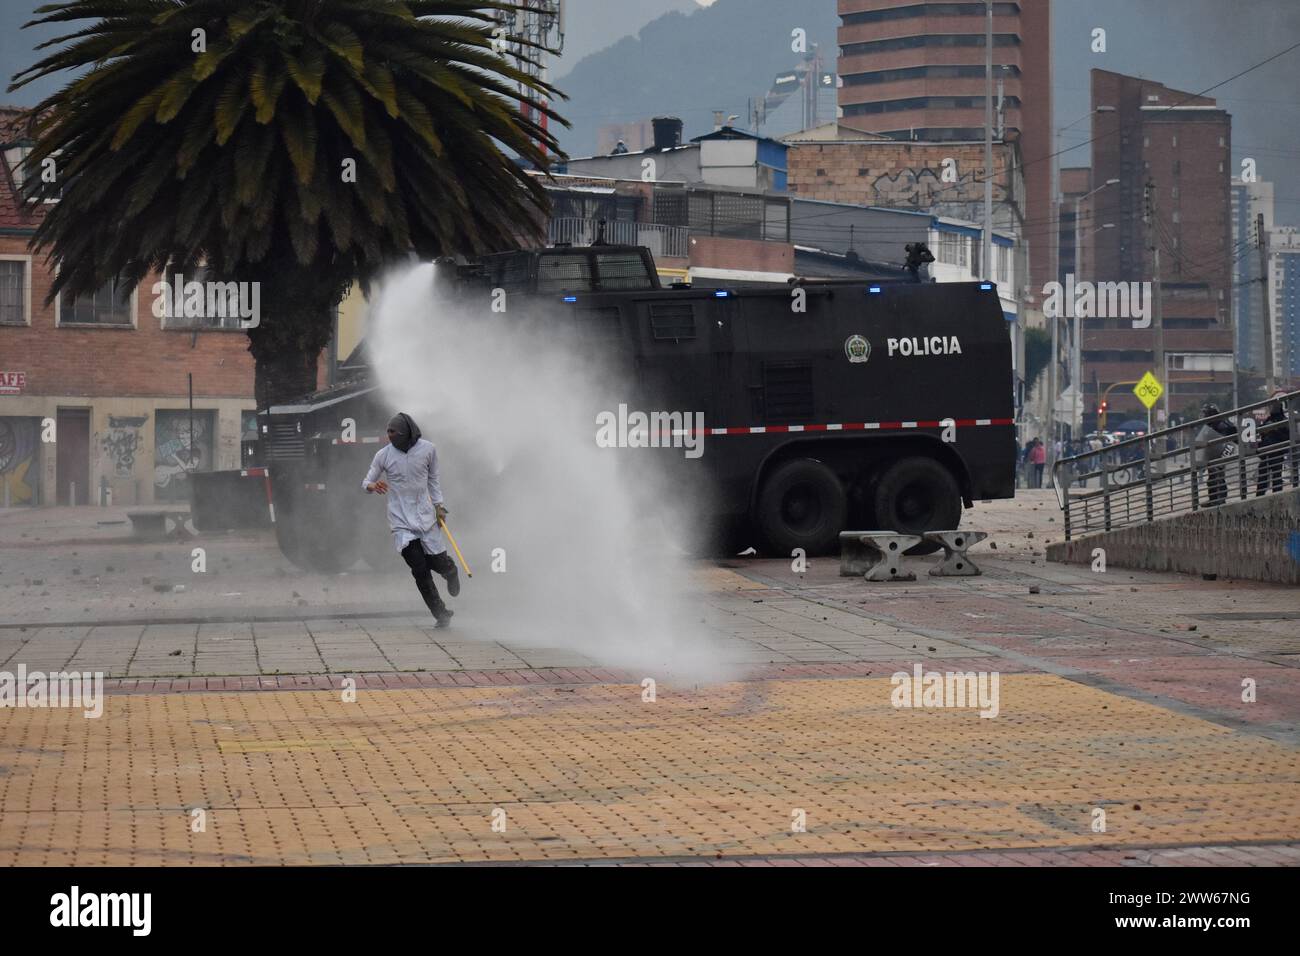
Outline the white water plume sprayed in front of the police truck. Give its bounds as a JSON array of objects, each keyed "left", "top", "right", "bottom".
[{"left": 367, "top": 264, "right": 736, "bottom": 683}]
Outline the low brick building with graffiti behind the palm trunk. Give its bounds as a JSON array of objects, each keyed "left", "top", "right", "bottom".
[{"left": 0, "top": 109, "right": 262, "bottom": 506}]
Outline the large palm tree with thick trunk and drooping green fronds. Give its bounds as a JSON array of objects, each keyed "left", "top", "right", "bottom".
[{"left": 9, "top": 0, "right": 564, "bottom": 407}]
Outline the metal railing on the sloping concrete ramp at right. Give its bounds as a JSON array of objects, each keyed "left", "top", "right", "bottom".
[{"left": 1052, "top": 392, "right": 1300, "bottom": 540}]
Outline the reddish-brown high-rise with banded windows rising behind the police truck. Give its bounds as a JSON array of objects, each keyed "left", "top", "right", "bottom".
[{"left": 839, "top": 0, "right": 1056, "bottom": 289}]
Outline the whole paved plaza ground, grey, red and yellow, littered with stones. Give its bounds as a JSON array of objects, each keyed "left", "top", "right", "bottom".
[{"left": 0, "top": 492, "right": 1300, "bottom": 866}]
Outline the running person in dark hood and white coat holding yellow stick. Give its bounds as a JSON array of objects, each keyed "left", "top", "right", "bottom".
[{"left": 361, "top": 412, "right": 460, "bottom": 627}]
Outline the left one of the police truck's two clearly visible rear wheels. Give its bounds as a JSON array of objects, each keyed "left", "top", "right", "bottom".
[{"left": 755, "top": 458, "right": 849, "bottom": 557}]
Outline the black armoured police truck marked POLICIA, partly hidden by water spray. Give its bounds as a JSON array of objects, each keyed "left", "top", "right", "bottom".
[{"left": 218, "top": 246, "right": 1015, "bottom": 571}]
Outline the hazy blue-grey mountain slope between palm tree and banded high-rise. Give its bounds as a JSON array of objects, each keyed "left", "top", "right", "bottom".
[{"left": 556, "top": 0, "right": 840, "bottom": 156}]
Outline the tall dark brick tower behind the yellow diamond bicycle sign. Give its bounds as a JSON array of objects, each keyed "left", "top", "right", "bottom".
[{"left": 1082, "top": 70, "right": 1234, "bottom": 420}]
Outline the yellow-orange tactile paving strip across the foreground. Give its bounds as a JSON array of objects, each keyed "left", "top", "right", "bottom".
[{"left": 0, "top": 675, "right": 1300, "bottom": 865}]
